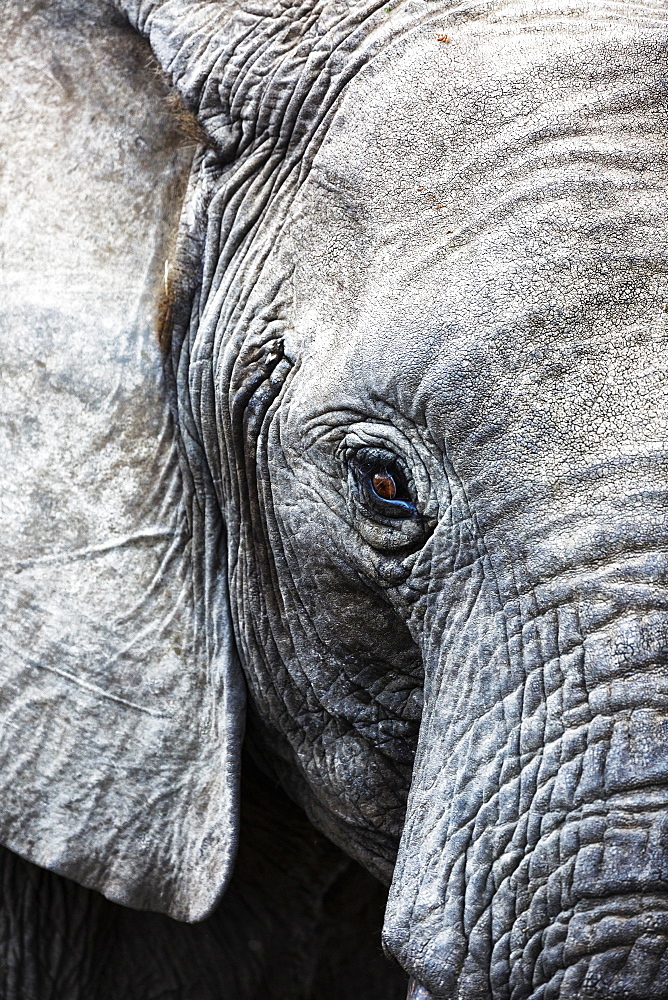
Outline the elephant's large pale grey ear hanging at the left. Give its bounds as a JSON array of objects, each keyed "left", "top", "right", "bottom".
[{"left": 0, "top": 0, "right": 244, "bottom": 920}]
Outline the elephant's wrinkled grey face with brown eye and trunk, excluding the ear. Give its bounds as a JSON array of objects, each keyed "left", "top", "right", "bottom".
[{"left": 213, "top": 7, "right": 668, "bottom": 998}]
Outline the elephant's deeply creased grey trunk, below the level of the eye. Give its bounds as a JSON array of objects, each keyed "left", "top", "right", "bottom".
[{"left": 384, "top": 594, "right": 668, "bottom": 1000}]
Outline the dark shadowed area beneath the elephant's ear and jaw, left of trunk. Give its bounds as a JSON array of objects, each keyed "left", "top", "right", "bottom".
[{"left": 0, "top": 761, "right": 406, "bottom": 1000}]
